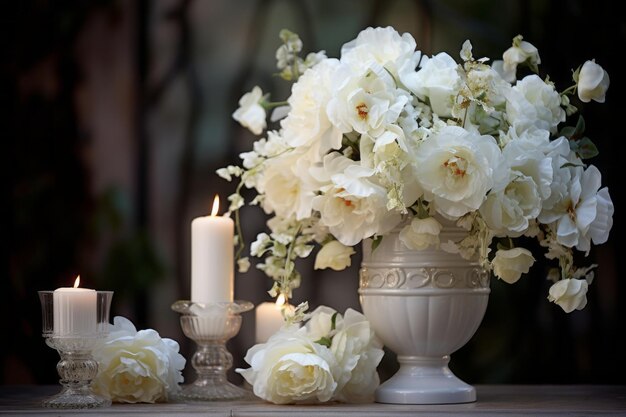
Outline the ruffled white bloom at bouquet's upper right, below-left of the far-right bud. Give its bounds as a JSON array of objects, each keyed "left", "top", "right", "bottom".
[{"left": 506, "top": 74, "right": 565, "bottom": 133}]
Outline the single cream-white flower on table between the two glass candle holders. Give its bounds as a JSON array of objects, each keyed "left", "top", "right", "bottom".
[{"left": 92, "top": 316, "right": 185, "bottom": 403}]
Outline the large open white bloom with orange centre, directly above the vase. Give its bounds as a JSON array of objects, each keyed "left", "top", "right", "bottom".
[{"left": 415, "top": 126, "right": 502, "bottom": 218}]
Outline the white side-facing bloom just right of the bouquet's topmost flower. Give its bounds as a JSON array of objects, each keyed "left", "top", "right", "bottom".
[{"left": 402, "top": 52, "right": 461, "bottom": 117}]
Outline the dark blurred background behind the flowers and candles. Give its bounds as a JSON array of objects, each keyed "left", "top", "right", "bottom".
[{"left": 0, "top": 0, "right": 626, "bottom": 384}]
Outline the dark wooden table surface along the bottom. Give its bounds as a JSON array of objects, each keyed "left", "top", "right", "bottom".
[{"left": 0, "top": 385, "right": 626, "bottom": 417}]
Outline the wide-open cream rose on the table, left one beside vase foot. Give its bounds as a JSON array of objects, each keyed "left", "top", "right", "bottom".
[{"left": 237, "top": 327, "right": 337, "bottom": 404}]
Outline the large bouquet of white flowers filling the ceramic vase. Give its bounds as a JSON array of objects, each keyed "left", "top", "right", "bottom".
[{"left": 217, "top": 27, "right": 614, "bottom": 312}]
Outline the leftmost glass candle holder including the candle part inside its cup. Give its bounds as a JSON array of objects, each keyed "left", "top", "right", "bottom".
[{"left": 39, "top": 291, "right": 113, "bottom": 409}]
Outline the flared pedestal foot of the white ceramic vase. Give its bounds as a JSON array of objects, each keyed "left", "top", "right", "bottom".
[{"left": 376, "top": 356, "right": 476, "bottom": 404}]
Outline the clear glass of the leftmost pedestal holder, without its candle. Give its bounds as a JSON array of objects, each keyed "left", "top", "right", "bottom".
[{"left": 39, "top": 291, "right": 113, "bottom": 409}]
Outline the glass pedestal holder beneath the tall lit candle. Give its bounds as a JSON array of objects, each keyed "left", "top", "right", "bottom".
[{"left": 172, "top": 300, "right": 254, "bottom": 401}]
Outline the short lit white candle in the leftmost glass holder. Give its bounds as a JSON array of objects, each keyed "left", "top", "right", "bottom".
[{"left": 52, "top": 276, "right": 98, "bottom": 336}]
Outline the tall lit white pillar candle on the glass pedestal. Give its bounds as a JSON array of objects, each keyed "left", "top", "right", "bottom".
[{"left": 191, "top": 196, "right": 235, "bottom": 303}]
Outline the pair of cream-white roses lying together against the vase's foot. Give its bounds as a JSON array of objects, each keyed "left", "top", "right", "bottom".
[{"left": 237, "top": 303, "right": 383, "bottom": 404}]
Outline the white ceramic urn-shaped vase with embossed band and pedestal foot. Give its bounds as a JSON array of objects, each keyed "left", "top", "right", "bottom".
[{"left": 359, "top": 219, "right": 490, "bottom": 404}]
